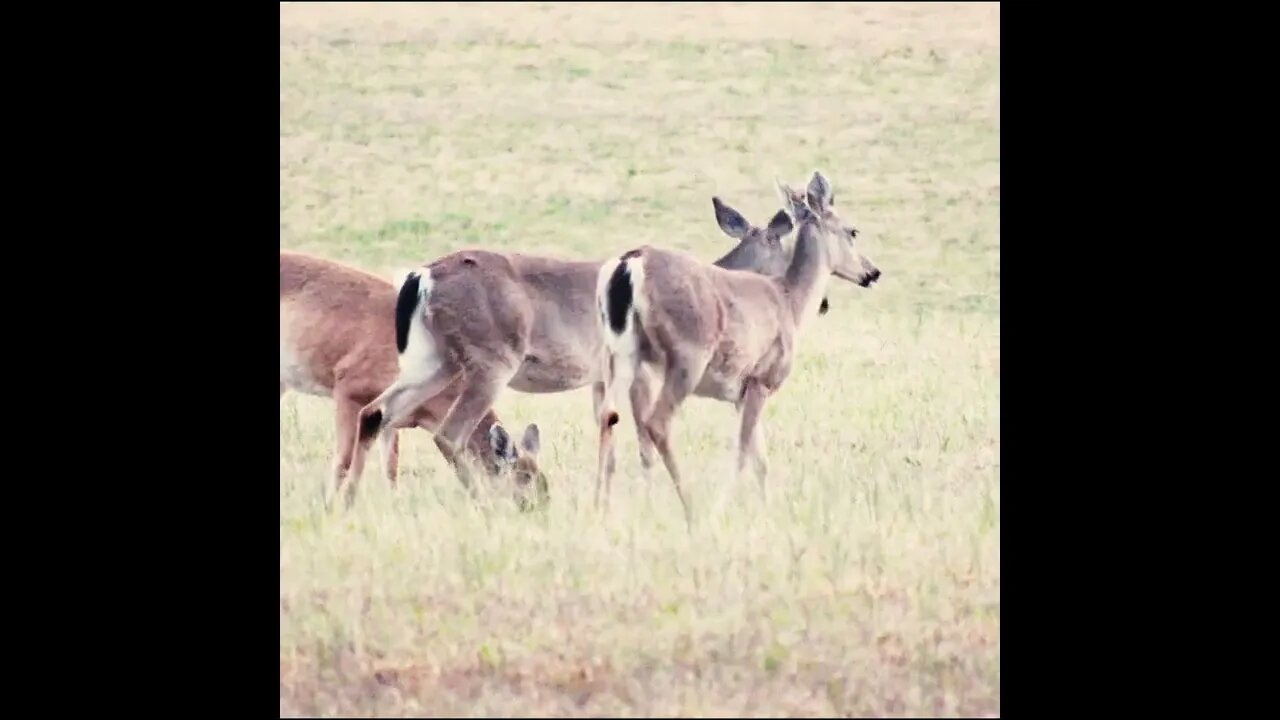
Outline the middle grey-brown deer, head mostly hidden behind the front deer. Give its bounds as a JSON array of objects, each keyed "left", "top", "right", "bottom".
[{"left": 355, "top": 193, "right": 791, "bottom": 487}]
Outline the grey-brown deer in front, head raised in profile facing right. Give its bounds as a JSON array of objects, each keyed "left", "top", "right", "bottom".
[{"left": 595, "top": 172, "right": 881, "bottom": 521}]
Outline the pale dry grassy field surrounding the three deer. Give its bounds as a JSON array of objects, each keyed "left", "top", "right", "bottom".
[{"left": 280, "top": 4, "right": 1000, "bottom": 716}]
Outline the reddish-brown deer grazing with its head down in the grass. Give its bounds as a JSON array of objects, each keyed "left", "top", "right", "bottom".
[{"left": 280, "top": 250, "right": 547, "bottom": 507}]
